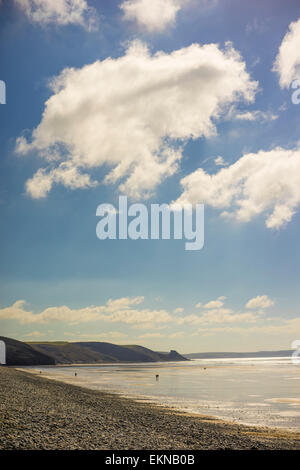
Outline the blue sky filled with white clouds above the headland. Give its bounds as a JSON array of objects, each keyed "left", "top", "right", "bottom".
[{"left": 0, "top": 0, "right": 300, "bottom": 353}]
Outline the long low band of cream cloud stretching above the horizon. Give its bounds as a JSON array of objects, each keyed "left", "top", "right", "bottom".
[{"left": 0, "top": 296, "right": 264, "bottom": 326}]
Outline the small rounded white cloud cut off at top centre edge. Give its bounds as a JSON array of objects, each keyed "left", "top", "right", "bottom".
[{"left": 120, "top": 0, "right": 190, "bottom": 33}]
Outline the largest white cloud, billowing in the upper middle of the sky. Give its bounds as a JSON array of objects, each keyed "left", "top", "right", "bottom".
[{"left": 17, "top": 42, "right": 257, "bottom": 198}]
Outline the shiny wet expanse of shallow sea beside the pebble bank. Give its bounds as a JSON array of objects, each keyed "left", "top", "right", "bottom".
[{"left": 31, "top": 357, "right": 300, "bottom": 430}]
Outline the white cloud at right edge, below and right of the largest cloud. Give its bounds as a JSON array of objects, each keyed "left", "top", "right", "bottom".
[{"left": 176, "top": 147, "right": 300, "bottom": 228}]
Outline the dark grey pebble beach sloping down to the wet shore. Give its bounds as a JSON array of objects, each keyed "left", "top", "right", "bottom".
[{"left": 0, "top": 367, "right": 300, "bottom": 450}]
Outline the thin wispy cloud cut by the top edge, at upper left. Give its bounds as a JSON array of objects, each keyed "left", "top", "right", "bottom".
[{"left": 14, "top": 0, "right": 97, "bottom": 31}]
